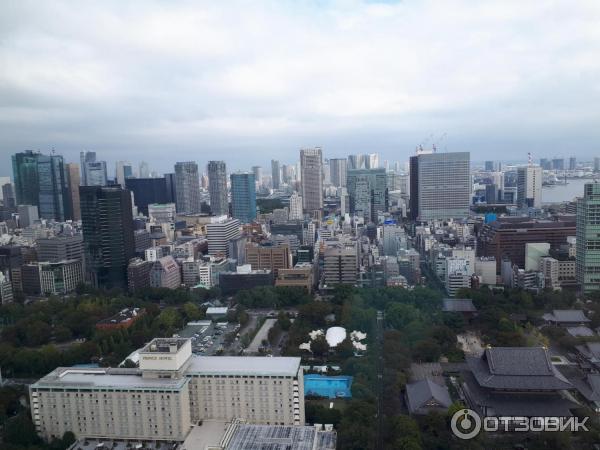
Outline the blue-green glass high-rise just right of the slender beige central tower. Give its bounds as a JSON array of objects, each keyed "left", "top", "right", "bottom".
[{"left": 348, "top": 169, "right": 388, "bottom": 221}]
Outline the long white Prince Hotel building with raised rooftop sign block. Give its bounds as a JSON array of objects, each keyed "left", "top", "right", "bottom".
[{"left": 29, "top": 338, "right": 304, "bottom": 441}]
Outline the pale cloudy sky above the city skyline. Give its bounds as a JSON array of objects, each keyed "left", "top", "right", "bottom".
[{"left": 0, "top": 0, "right": 600, "bottom": 176}]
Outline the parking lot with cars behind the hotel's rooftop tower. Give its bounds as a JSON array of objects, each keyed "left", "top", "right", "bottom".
[{"left": 177, "top": 320, "right": 239, "bottom": 356}]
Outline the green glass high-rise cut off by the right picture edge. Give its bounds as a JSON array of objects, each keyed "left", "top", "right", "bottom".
[{"left": 575, "top": 183, "right": 600, "bottom": 292}]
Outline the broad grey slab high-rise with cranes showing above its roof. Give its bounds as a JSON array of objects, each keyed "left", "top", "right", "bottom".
[{"left": 410, "top": 152, "right": 471, "bottom": 221}]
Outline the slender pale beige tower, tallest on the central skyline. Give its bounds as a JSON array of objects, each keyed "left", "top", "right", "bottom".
[{"left": 300, "top": 147, "right": 323, "bottom": 213}]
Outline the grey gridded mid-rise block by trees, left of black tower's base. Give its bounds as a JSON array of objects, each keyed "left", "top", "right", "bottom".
[{"left": 38, "top": 259, "right": 84, "bottom": 295}]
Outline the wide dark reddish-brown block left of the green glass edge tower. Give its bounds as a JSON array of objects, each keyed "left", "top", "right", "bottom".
[{"left": 477, "top": 216, "right": 575, "bottom": 273}]
